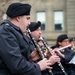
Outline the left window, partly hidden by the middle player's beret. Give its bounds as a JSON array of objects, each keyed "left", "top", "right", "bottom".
[{"left": 36, "top": 12, "right": 46, "bottom": 30}]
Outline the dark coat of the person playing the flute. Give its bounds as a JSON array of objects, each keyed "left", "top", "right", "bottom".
[{"left": 53, "top": 46, "right": 75, "bottom": 75}]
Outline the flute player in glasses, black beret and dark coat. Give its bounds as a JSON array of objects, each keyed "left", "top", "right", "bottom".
[{"left": 51, "top": 34, "right": 75, "bottom": 75}]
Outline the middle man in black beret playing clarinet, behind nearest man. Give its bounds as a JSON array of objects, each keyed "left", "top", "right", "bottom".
[{"left": 29, "top": 21, "right": 60, "bottom": 75}]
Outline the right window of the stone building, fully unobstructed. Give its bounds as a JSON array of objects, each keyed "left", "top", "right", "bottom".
[{"left": 54, "top": 11, "right": 64, "bottom": 31}]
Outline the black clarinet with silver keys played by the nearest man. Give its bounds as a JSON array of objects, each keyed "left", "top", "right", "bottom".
[{"left": 27, "top": 29, "right": 53, "bottom": 75}]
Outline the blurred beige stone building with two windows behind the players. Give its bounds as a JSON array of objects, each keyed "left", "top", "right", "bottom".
[{"left": 0, "top": 0, "right": 75, "bottom": 46}]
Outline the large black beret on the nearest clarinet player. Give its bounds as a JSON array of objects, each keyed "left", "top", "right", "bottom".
[{"left": 6, "top": 3, "right": 31, "bottom": 18}]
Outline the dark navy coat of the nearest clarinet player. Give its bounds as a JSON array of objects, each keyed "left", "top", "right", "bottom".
[{"left": 0, "top": 20, "right": 41, "bottom": 75}]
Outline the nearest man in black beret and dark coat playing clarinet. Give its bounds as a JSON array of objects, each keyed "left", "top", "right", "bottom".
[{"left": 0, "top": 2, "right": 51, "bottom": 75}]
